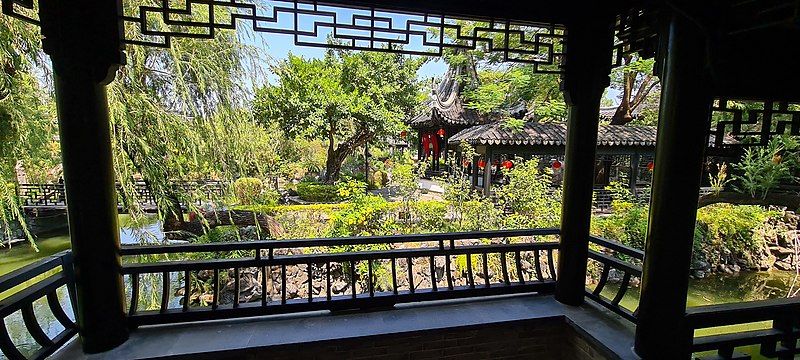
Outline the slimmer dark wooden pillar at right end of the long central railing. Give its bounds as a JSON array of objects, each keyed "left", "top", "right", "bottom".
[{"left": 556, "top": 20, "right": 613, "bottom": 305}]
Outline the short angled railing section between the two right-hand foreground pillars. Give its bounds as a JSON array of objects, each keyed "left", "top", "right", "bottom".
[{"left": 586, "top": 236, "right": 644, "bottom": 323}]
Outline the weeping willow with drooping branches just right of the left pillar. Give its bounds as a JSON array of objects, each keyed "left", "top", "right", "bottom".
[{"left": 109, "top": 1, "right": 278, "bottom": 239}]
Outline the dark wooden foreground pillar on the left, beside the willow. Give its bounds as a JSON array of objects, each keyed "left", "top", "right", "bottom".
[{"left": 40, "top": 0, "right": 128, "bottom": 353}]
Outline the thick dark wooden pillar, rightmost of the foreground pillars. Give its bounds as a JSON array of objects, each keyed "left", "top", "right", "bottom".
[{"left": 635, "top": 14, "right": 712, "bottom": 359}]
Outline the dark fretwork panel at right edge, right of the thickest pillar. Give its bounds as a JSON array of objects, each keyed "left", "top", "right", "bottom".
[{"left": 711, "top": 99, "right": 800, "bottom": 148}]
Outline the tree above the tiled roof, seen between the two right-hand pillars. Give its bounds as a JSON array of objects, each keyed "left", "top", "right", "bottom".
[{"left": 611, "top": 54, "right": 660, "bottom": 125}]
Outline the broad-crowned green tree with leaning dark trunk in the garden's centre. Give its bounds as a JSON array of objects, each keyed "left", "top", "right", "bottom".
[{"left": 254, "top": 51, "right": 423, "bottom": 184}]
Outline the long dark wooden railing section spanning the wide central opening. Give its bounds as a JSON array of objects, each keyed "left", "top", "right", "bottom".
[{"left": 122, "top": 229, "right": 559, "bottom": 326}]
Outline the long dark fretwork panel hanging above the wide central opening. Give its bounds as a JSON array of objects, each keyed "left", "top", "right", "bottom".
[{"left": 123, "top": 0, "right": 565, "bottom": 73}]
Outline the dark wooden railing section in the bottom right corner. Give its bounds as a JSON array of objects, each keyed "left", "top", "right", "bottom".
[{"left": 686, "top": 298, "right": 800, "bottom": 359}]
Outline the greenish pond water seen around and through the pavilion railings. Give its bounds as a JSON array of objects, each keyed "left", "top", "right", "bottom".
[{"left": 0, "top": 221, "right": 797, "bottom": 358}]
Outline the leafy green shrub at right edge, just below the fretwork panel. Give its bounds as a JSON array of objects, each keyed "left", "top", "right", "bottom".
[{"left": 733, "top": 137, "right": 798, "bottom": 199}]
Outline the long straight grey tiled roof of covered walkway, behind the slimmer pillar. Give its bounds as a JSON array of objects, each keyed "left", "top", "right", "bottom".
[{"left": 449, "top": 122, "right": 656, "bottom": 146}]
